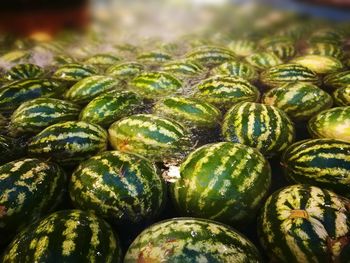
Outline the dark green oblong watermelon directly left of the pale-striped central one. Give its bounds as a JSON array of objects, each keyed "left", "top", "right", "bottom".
[{"left": 28, "top": 121, "right": 107, "bottom": 165}]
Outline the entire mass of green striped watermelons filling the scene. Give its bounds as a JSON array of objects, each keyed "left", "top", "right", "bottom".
[{"left": 0, "top": 2, "right": 350, "bottom": 263}]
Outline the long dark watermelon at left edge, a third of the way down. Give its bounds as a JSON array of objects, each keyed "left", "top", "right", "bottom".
[{"left": 0, "top": 79, "right": 64, "bottom": 111}]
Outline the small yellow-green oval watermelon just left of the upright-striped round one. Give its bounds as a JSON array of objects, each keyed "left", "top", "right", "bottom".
[{"left": 153, "top": 97, "right": 221, "bottom": 128}]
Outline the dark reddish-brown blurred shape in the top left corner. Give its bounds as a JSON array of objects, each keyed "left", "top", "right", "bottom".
[{"left": 0, "top": 0, "right": 90, "bottom": 40}]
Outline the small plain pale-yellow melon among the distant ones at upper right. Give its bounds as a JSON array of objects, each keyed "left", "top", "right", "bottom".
[{"left": 290, "top": 55, "right": 343, "bottom": 74}]
